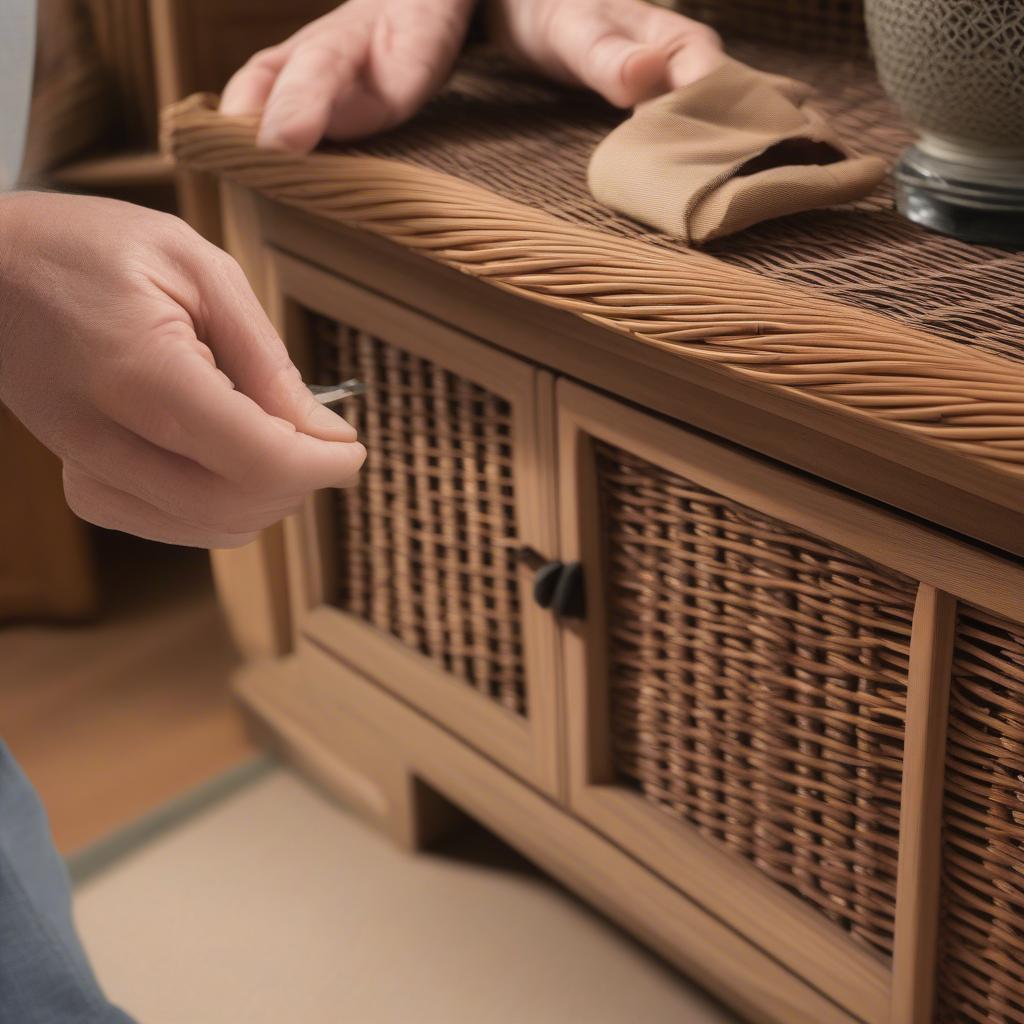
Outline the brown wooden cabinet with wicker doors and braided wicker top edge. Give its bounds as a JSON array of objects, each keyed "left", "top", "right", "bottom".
[{"left": 169, "top": 71, "right": 1024, "bottom": 1024}]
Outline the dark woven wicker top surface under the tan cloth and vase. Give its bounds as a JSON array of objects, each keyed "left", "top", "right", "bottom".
[{"left": 342, "top": 41, "right": 1024, "bottom": 372}]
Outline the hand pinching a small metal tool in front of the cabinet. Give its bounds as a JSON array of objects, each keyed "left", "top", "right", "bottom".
[{"left": 0, "top": 193, "right": 366, "bottom": 547}]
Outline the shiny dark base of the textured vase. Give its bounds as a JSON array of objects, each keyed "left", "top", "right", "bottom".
[{"left": 893, "top": 145, "right": 1024, "bottom": 250}]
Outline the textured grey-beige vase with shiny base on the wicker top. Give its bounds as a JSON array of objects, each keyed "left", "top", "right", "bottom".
[{"left": 865, "top": 0, "right": 1024, "bottom": 246}]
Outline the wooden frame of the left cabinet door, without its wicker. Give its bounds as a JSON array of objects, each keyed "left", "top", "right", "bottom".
[{"left": 267, "top": 253, "right": 559, "bottom": 796}]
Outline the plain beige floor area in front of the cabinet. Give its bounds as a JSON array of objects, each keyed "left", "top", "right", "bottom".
[{"left": 76, "top": 770, "right": 734, "bottom": 1024}]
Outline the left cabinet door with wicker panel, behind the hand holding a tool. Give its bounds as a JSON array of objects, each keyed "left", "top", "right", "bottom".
[{"left": 270, "top": 255, "right": 558, "bottom": 794}]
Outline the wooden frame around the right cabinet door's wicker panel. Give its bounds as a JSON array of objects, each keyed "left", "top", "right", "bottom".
[{"left": 557, "top": 381, "right": 1024, "bottom": 1024}]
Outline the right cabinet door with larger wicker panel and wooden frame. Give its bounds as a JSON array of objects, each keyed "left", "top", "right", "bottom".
[{"left": 557, "top": 382, "right": 978, "bottom": 1024}]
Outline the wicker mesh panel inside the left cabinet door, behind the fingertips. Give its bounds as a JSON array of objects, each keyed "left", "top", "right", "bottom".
[{"left": 309, "top": 315, "right": 526, "bottom": 715}]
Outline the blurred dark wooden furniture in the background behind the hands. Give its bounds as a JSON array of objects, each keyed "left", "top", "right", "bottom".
[{"left": 29, "top": 0, "right": 336, "bottom": 203}]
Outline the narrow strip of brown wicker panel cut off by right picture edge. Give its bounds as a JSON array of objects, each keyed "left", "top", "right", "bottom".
[{"left": 938, "top": 608, "right": 1024, "bottom": 1024}]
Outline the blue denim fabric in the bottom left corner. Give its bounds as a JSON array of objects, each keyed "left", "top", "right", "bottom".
[{"left": 0, "top": 741, "right": 132, "bottom": 1024}]
